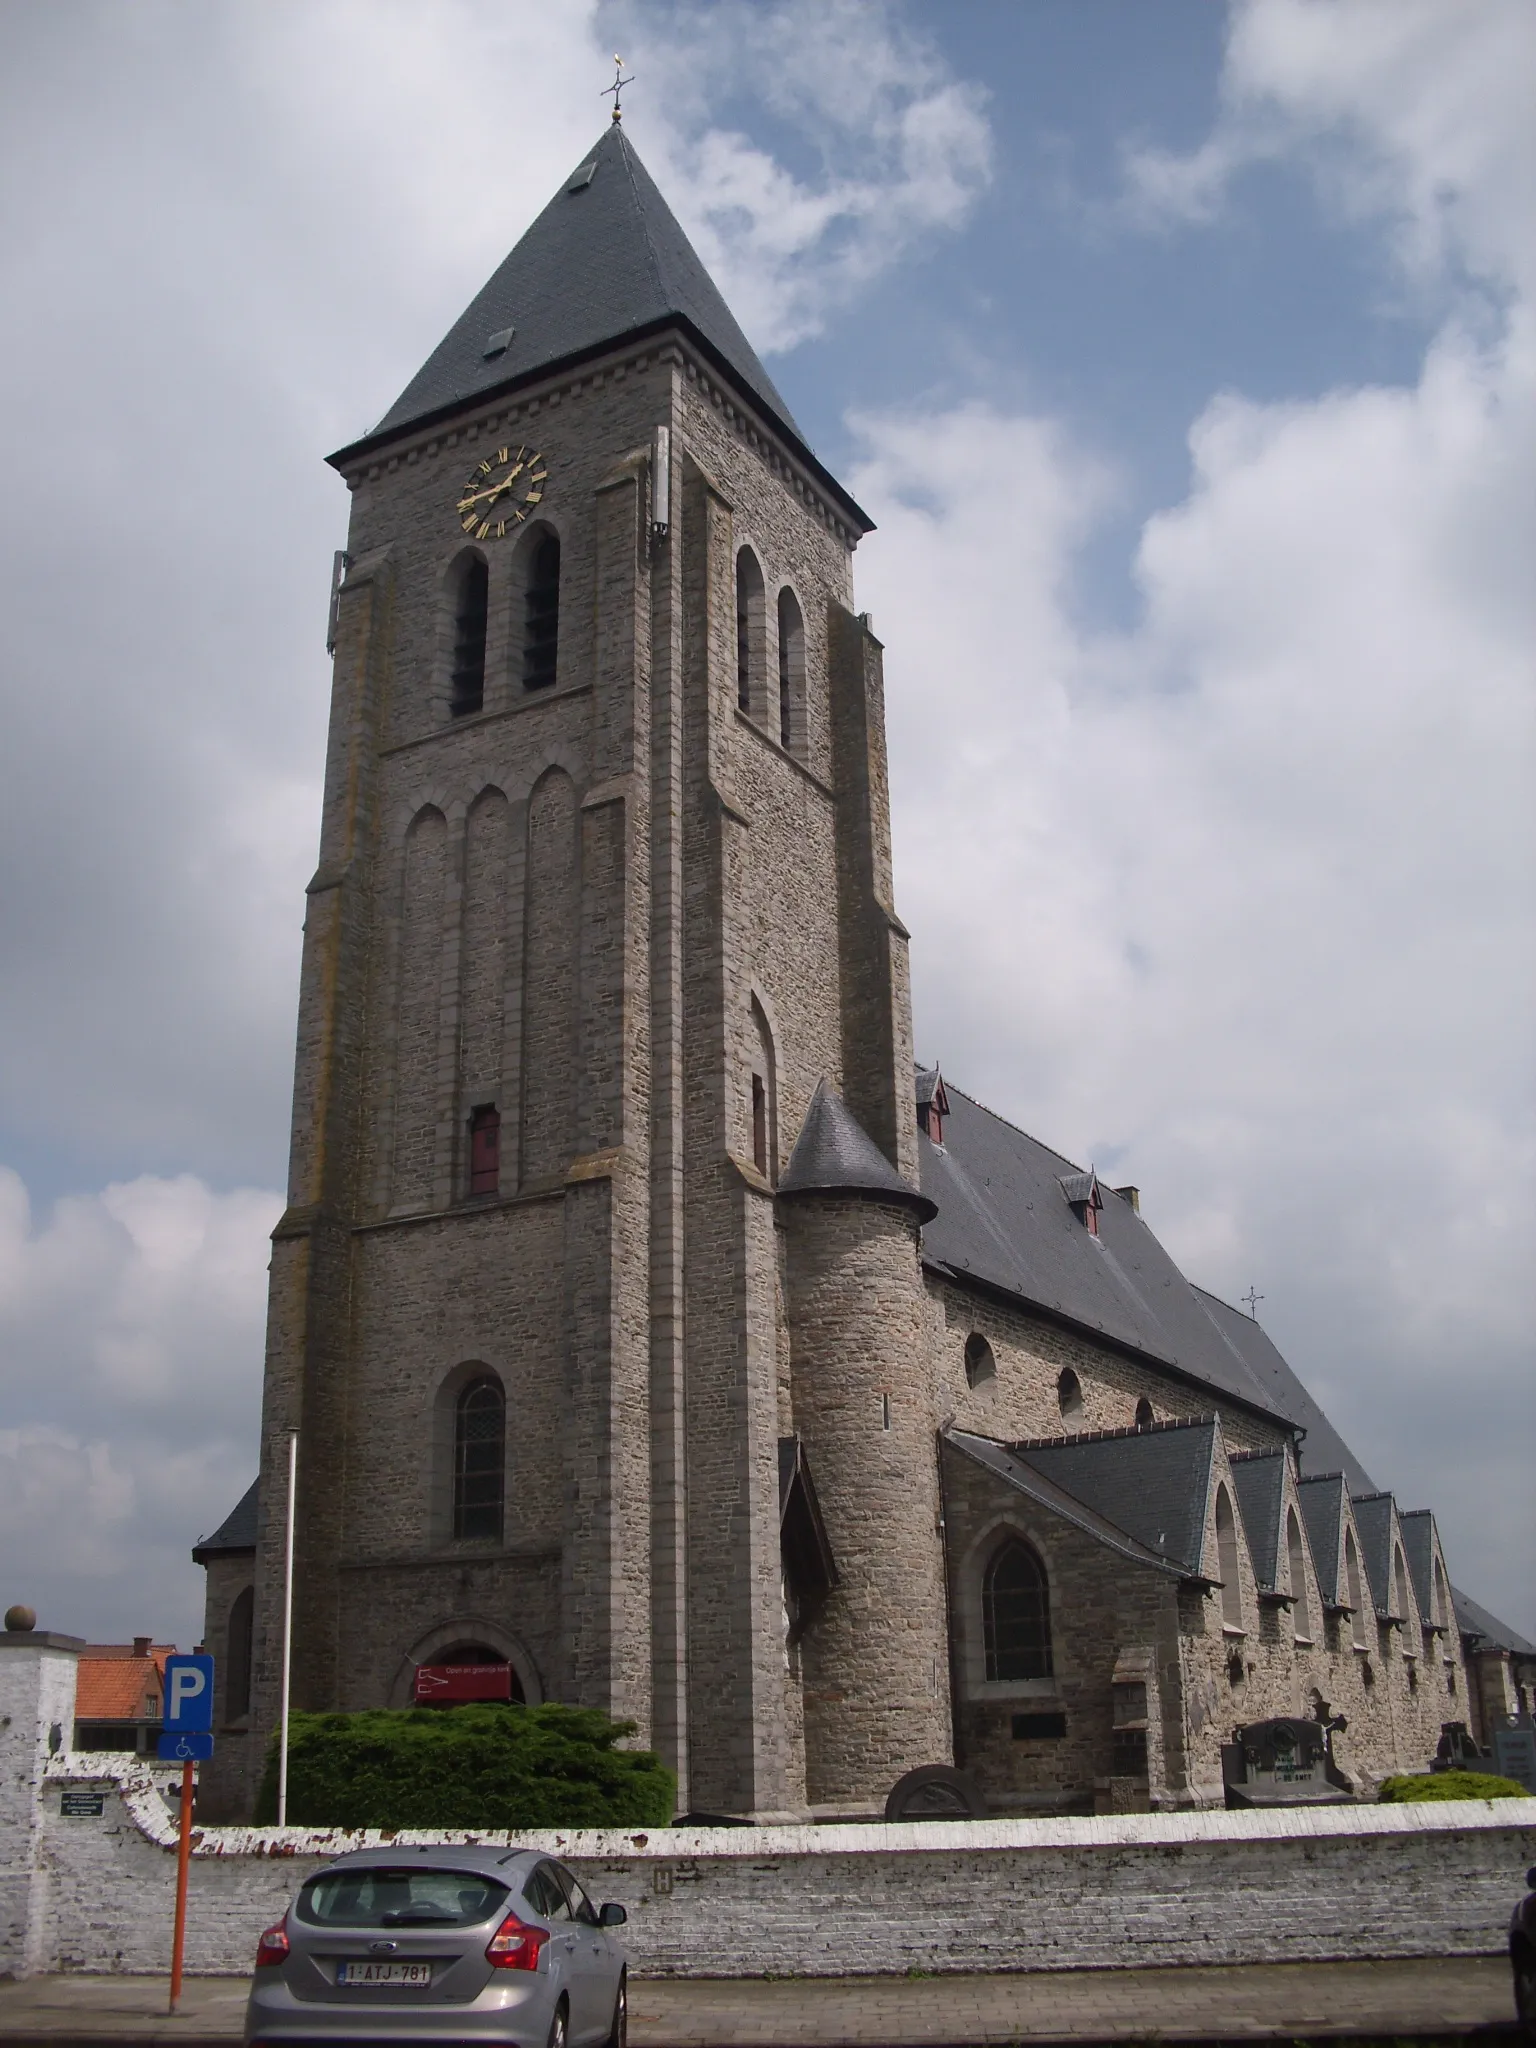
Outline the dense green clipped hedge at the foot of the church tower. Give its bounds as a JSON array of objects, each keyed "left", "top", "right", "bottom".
[{"left": 256, "top": 1704, "right": 678, "bottom": 1829}]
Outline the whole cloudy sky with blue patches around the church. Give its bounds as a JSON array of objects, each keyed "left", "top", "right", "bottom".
[{"left": 0, "top": 0, "right": 1536, "bottom": 1645}]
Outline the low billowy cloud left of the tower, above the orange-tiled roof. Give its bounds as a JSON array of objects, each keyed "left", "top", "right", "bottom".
[{"left": 0, "top": 1167, "right": 283, "bottom": 1645}]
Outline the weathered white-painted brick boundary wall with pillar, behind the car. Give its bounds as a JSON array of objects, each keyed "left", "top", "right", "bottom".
[{"left": 20, "top": 1755, "right": 1536, "bottom": 1976}]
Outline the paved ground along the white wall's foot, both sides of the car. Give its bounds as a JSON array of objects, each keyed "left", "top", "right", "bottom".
[{"left": 0, "top": 1956, "right": 1513, "bottom": 2048}]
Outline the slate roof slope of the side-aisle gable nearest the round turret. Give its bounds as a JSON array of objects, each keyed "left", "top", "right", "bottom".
[{"left": 1008, "top": 1417, "right": 1217, "bottom": 1577}]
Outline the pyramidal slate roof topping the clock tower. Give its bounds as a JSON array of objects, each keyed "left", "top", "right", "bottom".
[{"left": 346, "top": 123, "right": 803, "bottom": 453}]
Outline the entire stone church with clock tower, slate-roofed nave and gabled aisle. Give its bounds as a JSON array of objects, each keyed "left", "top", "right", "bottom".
[{"left": 195, "top": 117, "right": 1528, "bottom": 1821}]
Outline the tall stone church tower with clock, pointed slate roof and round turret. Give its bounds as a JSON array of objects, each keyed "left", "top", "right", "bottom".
[{"left": 209, "top": 121, "right": 950, "bottom": 1815}]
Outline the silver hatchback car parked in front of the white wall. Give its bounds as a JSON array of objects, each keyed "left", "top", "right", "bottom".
[{"left": 246, "top": 1849, "right": 629, "bottom": 2048}]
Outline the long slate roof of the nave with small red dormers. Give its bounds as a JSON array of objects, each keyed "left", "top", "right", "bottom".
[{"left": 918, "top": 1081, "right": 1370, "bottom": 1491}]
